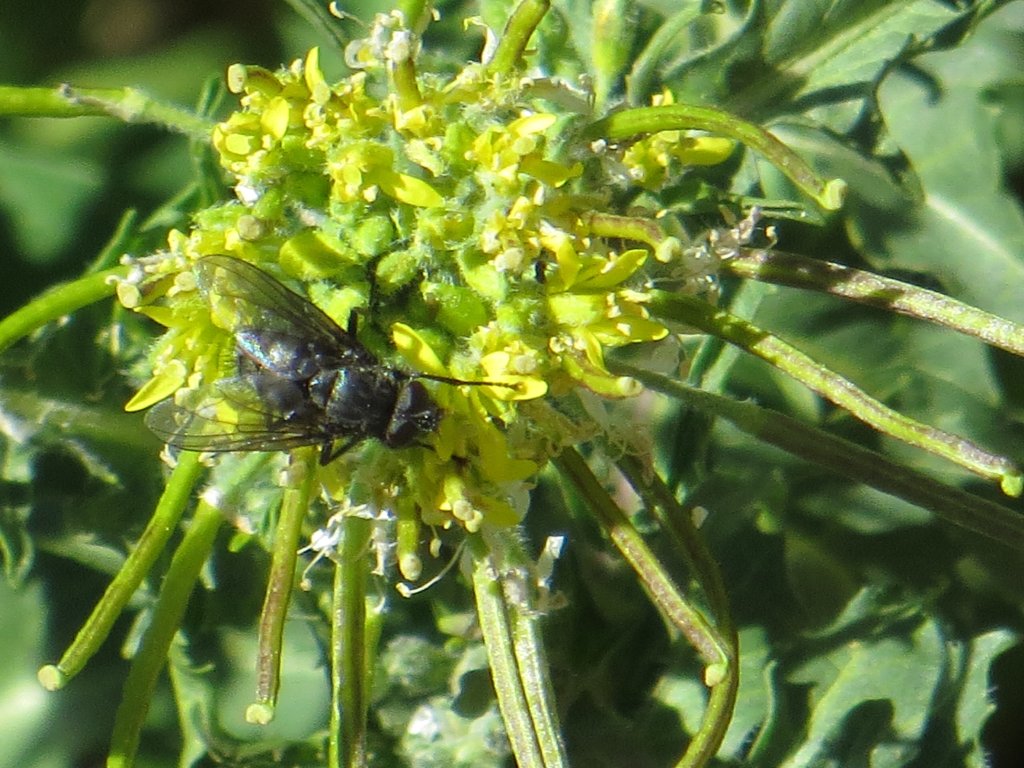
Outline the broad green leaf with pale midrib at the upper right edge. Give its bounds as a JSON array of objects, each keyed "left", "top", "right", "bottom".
[{"left": 868, "top": 4, "right": 1024, "bottom": 322}]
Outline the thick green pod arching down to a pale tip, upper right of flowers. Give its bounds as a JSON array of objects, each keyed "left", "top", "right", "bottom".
[{"left": 584, "top": 104, "right": 846, "bottom": 211}]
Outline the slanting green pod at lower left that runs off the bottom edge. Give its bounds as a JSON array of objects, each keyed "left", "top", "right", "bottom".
[{"left": 106, "top": 502, "right": 224, "bottom": 768}]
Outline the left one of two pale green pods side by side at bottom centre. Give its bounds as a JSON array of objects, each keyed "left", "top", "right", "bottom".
[{"left": 468, "top": 535, "right": 546, "bottom": 768}]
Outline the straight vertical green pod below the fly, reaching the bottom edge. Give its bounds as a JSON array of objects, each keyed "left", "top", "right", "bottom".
[{"left": 328, "top": 516, "right": 374, "bottom": 768}]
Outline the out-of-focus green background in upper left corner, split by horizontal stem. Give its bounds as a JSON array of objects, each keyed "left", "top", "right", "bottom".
[{"left": 0, "top": 0, "right": 284, "bottom": 305}]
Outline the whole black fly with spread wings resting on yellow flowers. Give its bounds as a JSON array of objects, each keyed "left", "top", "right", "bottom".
[{"left": 145, "top": 256, "right": 490, "bottom": 465}]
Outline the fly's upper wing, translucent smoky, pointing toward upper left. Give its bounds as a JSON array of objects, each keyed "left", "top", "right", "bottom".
[{"left": 196, "top": 255, "right": 376, "bottom": 365}]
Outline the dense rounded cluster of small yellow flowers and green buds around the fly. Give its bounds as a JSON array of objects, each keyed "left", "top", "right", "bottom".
[{"left": 120, "top": 14, "right": 732, "bottom": 552}]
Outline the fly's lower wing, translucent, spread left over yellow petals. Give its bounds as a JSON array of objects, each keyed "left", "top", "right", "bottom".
[{"left": 145, "top": 376, "right": 332, "bottom": 452}]
